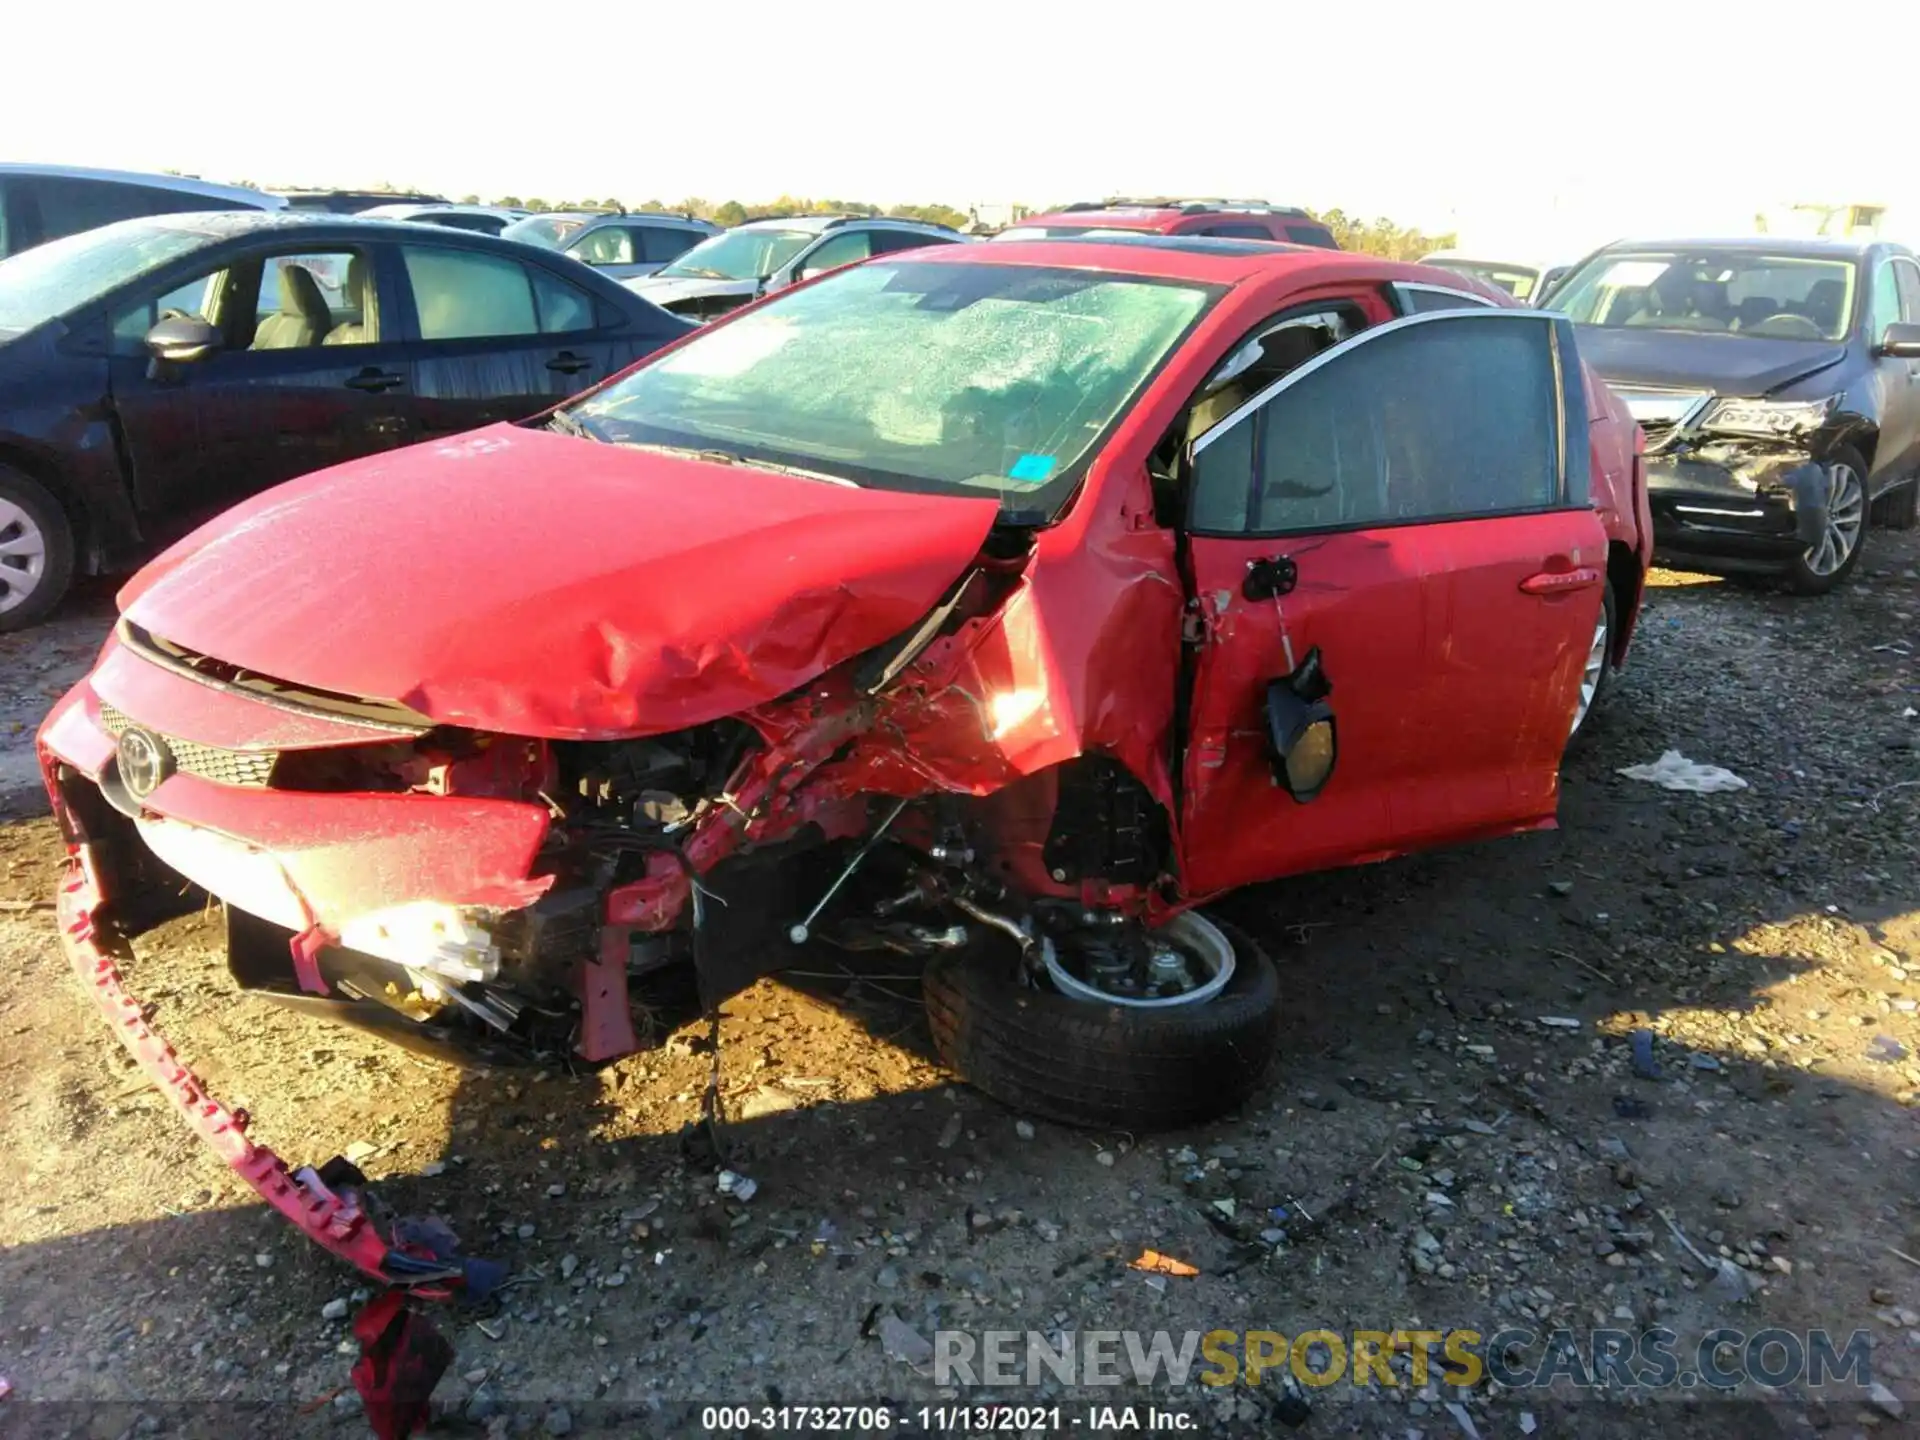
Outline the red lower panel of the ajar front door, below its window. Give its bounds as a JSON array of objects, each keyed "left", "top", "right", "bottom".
[{"left": 1183, "top": 511, "right": 1607, "bottom": 893}]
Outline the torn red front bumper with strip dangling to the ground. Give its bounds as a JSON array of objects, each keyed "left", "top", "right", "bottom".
[{"left": 38, "top": 670, "right": 545, "bottom": 1298}]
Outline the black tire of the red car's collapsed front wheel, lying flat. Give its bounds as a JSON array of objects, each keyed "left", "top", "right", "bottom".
[{"left": 922, "top": 916, "right": 1281, "bottom": 1131}]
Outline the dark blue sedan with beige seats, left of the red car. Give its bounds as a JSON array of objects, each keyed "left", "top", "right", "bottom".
[{"left": 0, "top": 209, "right": 693, "bottom": 630}]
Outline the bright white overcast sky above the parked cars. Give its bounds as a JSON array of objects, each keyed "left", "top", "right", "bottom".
[{"left": 15, "top": 0, "right": 1920, "bottom": 261}]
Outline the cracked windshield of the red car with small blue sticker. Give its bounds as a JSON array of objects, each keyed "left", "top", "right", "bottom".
[{"left": 568, "top": 263, "right": 1212, "bottom": 518}]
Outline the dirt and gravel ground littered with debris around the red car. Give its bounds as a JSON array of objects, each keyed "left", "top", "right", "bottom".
[{"left": 0, "top": 532, "right": 1920, "bottom": 1440}]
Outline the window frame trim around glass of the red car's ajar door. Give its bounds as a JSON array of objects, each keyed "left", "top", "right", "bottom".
[{"left": 1181, "top": 309, "right": 1594, "bottom": 540}]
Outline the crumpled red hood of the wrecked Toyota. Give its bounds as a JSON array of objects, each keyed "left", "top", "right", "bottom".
[{"left": 119, "top": 424, "right": 996, "bottom": 739}]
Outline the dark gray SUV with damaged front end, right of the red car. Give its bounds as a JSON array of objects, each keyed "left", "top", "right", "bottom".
[{"left": 1549, "top": 236, "right": 1920, "bottom": 595}]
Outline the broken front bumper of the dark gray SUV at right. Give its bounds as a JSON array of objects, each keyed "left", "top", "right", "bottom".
[{"left": 1647, "top": 455, "right": 1828, "bottom": 574}]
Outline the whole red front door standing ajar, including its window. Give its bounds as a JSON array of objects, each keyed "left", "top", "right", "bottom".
[{"left": 1181, "top": 309, "right": 1607, "bottom": 895}]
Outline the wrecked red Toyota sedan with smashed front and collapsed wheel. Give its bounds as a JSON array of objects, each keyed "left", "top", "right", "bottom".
[{"left": 40, "top": 236, "right": 1649, "bottom": 1273}]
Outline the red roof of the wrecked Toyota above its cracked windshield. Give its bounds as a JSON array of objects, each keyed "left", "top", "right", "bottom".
[{"left": 887, "top": 234, "right": 1428, "bottom": 286}]
